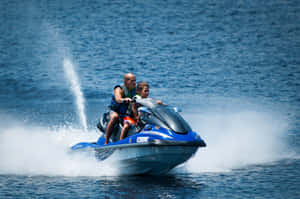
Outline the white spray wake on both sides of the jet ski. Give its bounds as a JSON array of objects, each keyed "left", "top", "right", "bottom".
[{"left": 0, "top": 111, "right": 296, "bottom": 176}]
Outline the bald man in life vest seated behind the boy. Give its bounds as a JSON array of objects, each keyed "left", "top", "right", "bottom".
[{"left": 104, "top": 73, "right": 136, "bottom": 144}]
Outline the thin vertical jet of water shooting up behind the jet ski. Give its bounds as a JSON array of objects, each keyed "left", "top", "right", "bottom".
[{"left": 64, "top": 58, "right": 87, "bottom": 131}]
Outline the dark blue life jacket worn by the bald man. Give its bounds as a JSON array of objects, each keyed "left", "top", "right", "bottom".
[{"left": 109, "top": 84, "right": 136, "bottom": 115}]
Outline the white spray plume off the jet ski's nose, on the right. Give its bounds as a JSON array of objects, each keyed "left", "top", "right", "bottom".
[{"left": 185, "top": 111, "right": 294, "bottom": 172}]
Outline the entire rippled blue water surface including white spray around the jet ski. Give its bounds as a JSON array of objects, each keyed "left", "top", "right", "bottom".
[{"left": 0, "top": 0, "right": 300, "bottom": 199}]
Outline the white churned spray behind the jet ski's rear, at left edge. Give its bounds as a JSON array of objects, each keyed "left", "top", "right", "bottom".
[{"left": 0, "top": 124, "right": 118, "bottom": 176}]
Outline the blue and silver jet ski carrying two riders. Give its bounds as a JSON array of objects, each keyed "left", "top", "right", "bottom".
[{"left": 71, "top": 98, "right": 206, "bottom": 175}]
